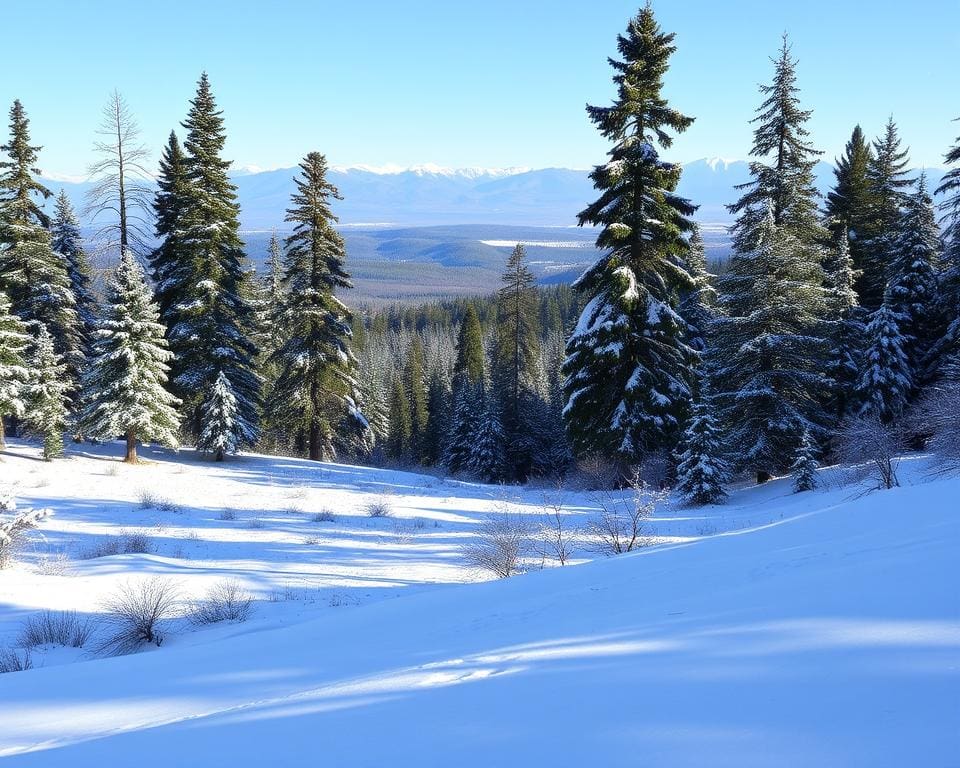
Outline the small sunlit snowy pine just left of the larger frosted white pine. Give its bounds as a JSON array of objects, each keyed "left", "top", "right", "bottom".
[{"left": 26, "top": 325, "right": 72, "bottom": 461}]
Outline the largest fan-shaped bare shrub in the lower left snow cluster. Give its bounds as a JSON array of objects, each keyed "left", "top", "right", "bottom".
[{"left": 97, "top": 576, "right": 179, "bottom": 654}]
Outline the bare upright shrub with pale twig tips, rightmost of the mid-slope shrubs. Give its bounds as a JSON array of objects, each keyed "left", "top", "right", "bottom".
[{"left": 588, "top": 473, "right": 669, "bottom": 555}]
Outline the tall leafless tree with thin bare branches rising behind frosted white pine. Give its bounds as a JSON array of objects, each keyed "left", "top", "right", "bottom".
[{"left": 84, "top": 91, "right": 153, "bottom": 255}]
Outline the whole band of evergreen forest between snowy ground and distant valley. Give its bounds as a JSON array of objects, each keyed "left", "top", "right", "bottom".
[{"left": 0, "top": 6, "right": 960, "bottom": 503}]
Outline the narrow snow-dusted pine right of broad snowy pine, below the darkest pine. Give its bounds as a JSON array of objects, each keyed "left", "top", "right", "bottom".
[{"left": 823, "top": 231, "right": 865, "bottom": 420}]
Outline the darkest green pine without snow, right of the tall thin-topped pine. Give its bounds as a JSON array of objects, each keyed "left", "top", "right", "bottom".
[{"left": 825, "top": 125, "right": 873, "bottom": 297}]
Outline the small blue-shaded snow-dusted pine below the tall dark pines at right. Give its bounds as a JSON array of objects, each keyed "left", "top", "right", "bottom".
[{"left": 856, "top": 301, "right": 913, "bottom": 424}]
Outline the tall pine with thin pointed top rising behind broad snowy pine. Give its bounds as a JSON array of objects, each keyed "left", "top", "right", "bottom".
[{"left": 729, "top": 35, "right": 824, "bottom": 252}]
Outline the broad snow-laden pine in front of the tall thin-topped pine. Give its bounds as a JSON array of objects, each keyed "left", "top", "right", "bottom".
[{"left": 713, "top": 206, "right": 830, "bottom": 482}]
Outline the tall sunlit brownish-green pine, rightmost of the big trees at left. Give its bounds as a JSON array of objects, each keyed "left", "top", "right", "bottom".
[{"left": 272, "top": 152, "right": 369, "bottom": 461}]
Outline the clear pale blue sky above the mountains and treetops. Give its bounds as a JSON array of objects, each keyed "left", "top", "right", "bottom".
[{"left": 0, "top": 0, "right": 960, "bottom": 174}]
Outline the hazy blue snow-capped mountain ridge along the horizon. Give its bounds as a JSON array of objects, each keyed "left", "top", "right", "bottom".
[{"left": 44, "top": 158, "right": 943, "bottom": 230}]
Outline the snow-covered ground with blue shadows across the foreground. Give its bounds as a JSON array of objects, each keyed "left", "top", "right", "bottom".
[{"left": 0, "top": 441, "right": 960, "bottom": 768}]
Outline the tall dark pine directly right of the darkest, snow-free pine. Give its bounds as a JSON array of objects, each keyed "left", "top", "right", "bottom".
[{"left": 860, "top": 117, "right": 911, "bottom": 311}]
